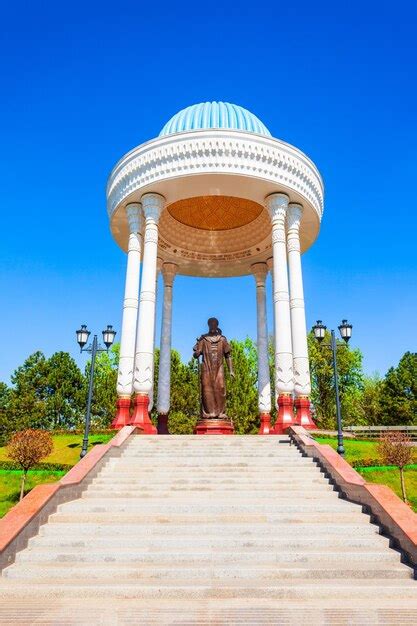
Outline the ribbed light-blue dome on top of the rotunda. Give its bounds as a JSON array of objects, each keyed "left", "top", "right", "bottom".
[{"left": 159, "top": 102, "right": 271, "bottom": 137}]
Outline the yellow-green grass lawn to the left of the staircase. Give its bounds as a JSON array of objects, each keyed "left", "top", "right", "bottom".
[{"left": 0, "top": 434, "right": 114, "bottom": 517}]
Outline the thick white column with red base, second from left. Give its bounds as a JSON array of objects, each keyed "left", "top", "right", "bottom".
[{"left": 132, "top": 193, "right": 165, "bottom": 434}]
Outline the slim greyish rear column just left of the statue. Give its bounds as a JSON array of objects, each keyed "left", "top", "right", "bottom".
[{"left": 157, "top": 263, "right": 178, "bottom": 435}]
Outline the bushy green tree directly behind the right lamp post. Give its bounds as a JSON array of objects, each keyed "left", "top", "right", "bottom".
[{"left": 308, "top": 331, "right": 363, "bottom": 428}]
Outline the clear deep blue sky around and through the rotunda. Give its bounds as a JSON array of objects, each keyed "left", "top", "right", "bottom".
[{"left": 0, "top": 0, "right": 417, "bottom": 381}]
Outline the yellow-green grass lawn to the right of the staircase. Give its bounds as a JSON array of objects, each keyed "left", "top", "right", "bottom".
[{"left": 315, "top": 437, "right": 417, "bottom": 512}]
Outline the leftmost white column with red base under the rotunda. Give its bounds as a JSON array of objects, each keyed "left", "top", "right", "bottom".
[{"left": 112, "top": 202, "right": 142, "bottom": 429}]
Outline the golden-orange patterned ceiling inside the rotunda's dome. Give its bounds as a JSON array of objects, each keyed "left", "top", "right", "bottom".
[{"left": 168, "top": 196, "right": 263, "bottom": 230}]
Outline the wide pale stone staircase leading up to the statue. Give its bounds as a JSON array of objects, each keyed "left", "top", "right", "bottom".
[{"left": 0, "top": 436, "right": 417, "bottom": 624}]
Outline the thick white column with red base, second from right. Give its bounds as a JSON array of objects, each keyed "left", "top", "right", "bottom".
[{"left": 266, "top": 193, "right": 294, "bottom": 434}]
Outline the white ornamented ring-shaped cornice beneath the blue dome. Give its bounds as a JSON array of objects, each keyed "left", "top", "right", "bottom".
[{"left": 107, "top": 130, "right": 323, "bottom": 218}]
